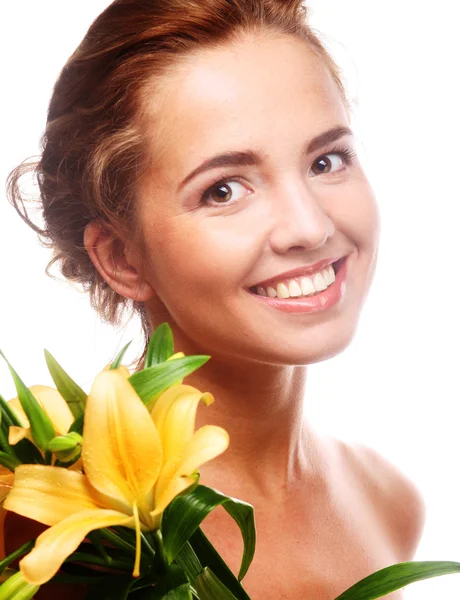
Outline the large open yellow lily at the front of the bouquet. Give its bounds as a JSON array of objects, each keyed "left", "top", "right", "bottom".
[{"left": 5, "top": 369, "right": 228, "bottom": 585}]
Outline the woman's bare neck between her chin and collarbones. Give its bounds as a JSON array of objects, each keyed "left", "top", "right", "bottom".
[{"left": 158, "top": 335, "right": 326, "bottom": 499}]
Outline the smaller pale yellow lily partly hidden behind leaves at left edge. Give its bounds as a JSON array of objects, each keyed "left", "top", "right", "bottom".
[{"left": 8, "top": 385, "right": 74, "bottom": 446}]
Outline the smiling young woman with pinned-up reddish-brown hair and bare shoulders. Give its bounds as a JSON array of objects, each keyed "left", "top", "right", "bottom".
[{"left": 6, "top": 0, "right": 424, "bottom": 600}]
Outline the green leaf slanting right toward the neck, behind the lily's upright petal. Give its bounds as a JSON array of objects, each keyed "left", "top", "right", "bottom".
[{"left": 128, "top": 355, "right": 211, "bottom": 410}]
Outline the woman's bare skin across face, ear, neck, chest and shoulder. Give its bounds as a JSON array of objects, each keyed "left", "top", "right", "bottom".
[{"left": 0, "top": 34, "right": 424, "bottom": 600}]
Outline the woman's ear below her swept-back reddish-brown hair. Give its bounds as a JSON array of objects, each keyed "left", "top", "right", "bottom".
[{"left": 83, "top": 221, "right": 155, "bottom": 302}]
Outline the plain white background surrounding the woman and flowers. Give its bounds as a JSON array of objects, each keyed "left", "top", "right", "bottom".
[{"left": 0, "top": 0, "right": 460, "bottom": 600}]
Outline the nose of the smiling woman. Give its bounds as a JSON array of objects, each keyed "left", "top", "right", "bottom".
[{"left": 270, "top": 181, "right": 335, "bottom": 254}]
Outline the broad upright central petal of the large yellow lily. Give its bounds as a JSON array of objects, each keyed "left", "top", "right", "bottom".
[{"left": 82, "top": 369, "right": 163, "bottom": 512}]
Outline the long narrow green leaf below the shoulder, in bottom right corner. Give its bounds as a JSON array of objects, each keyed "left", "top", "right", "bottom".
[{"left": 335, "top": 561, "right": 460, "bottom": 600}]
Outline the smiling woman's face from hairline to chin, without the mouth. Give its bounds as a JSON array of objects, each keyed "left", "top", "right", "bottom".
[{"left": 134, "top": 36, "right": 379, "bottom": 365}]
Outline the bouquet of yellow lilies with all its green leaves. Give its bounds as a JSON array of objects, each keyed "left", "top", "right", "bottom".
[{"left": 0, "top": 323, "right": 460, "bottom": 600}]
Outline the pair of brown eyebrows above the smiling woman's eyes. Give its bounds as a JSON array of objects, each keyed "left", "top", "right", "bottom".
[{"left": 179, "top": 125, "right": 353, "bottom": 190}]
